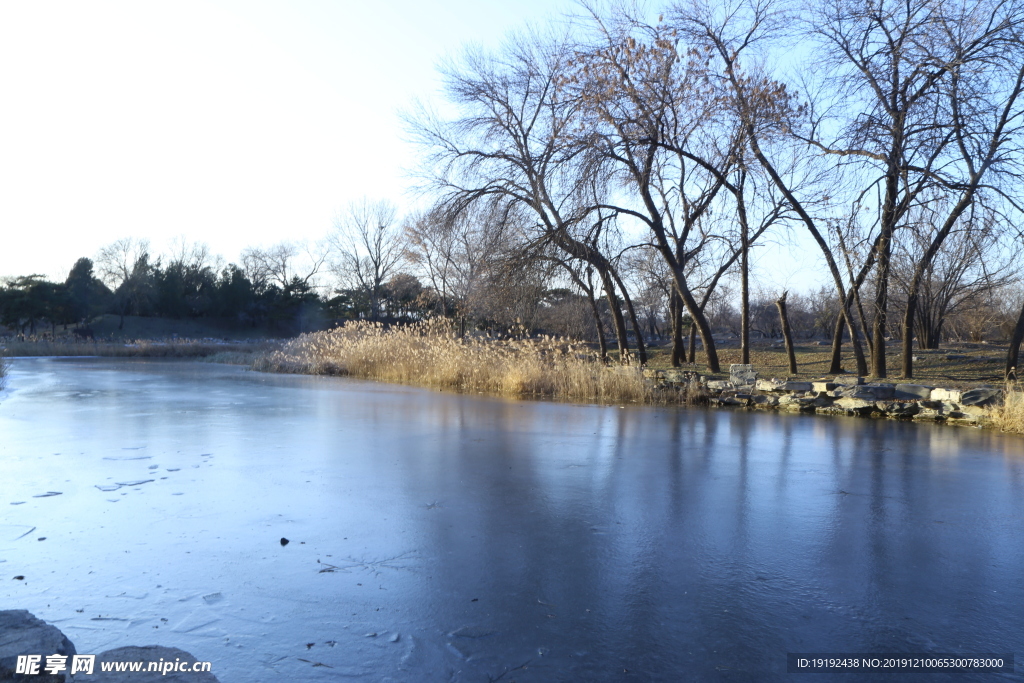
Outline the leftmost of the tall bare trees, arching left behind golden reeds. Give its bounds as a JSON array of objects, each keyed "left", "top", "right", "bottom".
[{"left": 410, "top": 31, "right": 631, "bottom": 362}]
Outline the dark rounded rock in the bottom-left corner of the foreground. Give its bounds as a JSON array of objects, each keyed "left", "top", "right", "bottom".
[{"left": 0, "top": 609, "right": 78, "bottom": 683}]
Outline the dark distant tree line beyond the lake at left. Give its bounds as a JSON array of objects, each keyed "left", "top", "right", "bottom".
[{"left": 0, "top": 239, "right": 436, "bottom": 334}]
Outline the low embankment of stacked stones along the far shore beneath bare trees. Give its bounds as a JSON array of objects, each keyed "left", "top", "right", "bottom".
[{"left": 644, "top": 365, "right": 1002, "bottom": 425}]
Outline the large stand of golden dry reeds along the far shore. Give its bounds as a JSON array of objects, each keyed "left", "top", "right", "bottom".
[{"left": 253, "top": 319, "right": 657, "bottom": 403}]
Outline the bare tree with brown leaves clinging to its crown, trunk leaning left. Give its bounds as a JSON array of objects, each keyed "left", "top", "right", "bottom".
[{"left": 562, "top": 9, "right": 735, "bottom": 372}]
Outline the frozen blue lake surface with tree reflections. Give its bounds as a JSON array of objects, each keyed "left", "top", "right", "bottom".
[{"left": 0, "top": 358, "right": 1024, "bottom": 683}]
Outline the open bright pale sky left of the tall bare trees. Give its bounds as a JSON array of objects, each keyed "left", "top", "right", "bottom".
[{"left": 0, "top": 0, "right": 573, "bottom": 280}]
